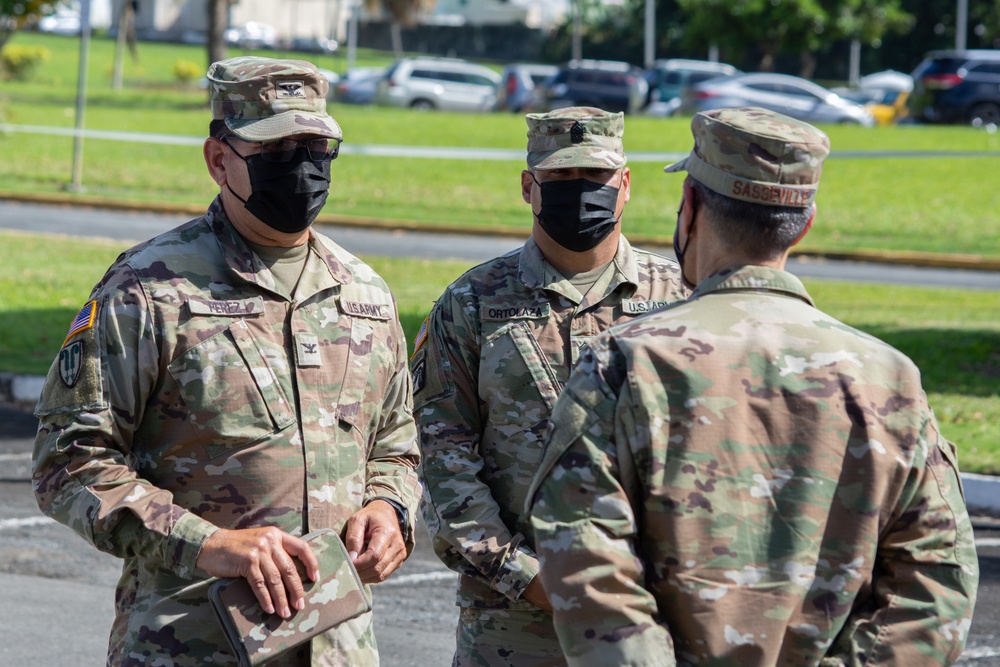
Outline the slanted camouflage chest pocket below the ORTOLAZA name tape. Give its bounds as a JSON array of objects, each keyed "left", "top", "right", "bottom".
[{"left": 479, "top": 321, "right": 562, "bottom": 437}]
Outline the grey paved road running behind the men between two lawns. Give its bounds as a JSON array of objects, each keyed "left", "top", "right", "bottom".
[{"left": 0, "top": 201, "right": 1000, "bottom": 290}]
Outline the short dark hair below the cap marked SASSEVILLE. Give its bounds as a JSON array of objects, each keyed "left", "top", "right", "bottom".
[{"left": 688, "top": 176, "right": 813, "bottom": 260}]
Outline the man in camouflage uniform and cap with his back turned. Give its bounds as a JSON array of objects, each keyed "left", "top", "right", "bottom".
[{"left": 529, "top": 108, "right": 978, "bottom": 667}]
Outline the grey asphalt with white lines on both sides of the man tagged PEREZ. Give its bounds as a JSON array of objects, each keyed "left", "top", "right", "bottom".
[{"left": 0, "top": 406, "right": 458, "bottom": 667}]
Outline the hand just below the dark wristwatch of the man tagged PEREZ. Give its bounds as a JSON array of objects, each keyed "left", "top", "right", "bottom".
[{"left": 344, "top": 500, "right": 406, "bottom": 584}]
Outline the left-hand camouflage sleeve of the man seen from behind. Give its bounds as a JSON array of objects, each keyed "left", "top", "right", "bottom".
[{"left": 528, "top": 337, "right": 676, "bottom": 667}]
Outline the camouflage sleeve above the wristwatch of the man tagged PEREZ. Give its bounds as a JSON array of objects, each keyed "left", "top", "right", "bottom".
[{"left": 364, "top": 294, "right": 420, "bottom": 553}]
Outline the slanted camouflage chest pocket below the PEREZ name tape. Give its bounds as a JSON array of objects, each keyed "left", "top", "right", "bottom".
[{"left": 168, "top": 320, "right": 295, "bottom": 458}]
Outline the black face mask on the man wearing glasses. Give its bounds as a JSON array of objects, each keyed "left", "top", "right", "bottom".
[{"left": 226, "top": 148, "right": 330, "bottom": 234}]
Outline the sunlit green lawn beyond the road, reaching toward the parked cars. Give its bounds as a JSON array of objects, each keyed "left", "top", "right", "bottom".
[{"left": 0, "top": 33, "right": 1000, "bottom": 259}]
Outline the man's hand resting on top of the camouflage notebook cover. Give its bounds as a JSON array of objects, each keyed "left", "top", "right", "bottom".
[{"left": 197, "top": 527, "right": 319, "bottom": 618}]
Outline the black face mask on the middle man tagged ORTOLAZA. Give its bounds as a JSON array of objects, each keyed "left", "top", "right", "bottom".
[{"left": 531, "top": 174, "right": 619, "bottom": 252}]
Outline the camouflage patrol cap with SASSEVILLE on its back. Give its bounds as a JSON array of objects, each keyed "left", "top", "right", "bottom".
[{"left": 663, "top": 107, "right": 830, "bottom": 208}]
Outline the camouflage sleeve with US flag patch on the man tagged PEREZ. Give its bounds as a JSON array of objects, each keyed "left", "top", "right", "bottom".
[{"left": 32, "top": 266, "right": 217, "bottom": 577}]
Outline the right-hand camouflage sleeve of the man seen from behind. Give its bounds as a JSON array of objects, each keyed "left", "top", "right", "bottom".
[{"left": 822, "top": 412, "right": 979, "bottom": 667}]
